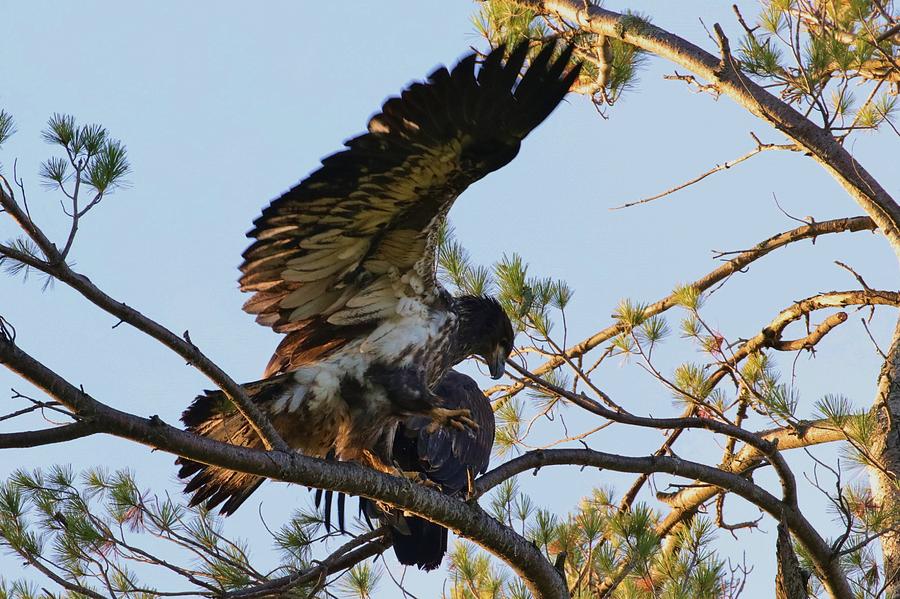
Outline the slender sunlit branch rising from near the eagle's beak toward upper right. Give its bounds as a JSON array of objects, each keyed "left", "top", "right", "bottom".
[{"left": 494, "top": 216, "right": 876, "bottom": 411}]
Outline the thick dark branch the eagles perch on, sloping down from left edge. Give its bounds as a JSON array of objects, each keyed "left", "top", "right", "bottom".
[{"left": 0, "top": 337, "right": 568, "bottom": 599}]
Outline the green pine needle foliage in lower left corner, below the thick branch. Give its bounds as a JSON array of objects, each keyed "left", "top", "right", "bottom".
[{"left": 0, "top": 466, "right": 330, "bottom": 599}]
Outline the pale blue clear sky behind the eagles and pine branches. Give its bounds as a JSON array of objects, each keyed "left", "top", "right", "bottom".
[{"left": 0, "top": 0, "right": 900, "bottom": 598}]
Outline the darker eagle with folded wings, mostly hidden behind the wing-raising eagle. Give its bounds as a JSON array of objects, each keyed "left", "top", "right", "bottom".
[{"left": 316, "top": 370, "right": 495, "bottom": 570}]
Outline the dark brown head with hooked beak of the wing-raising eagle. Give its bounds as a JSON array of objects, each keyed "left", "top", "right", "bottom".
[{"left": 453, "top": 295, "right": 515, "bottom": 379}]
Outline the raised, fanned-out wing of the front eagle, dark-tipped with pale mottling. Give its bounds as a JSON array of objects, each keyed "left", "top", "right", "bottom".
[{"left": 240, "top": 43, "right": 579, "bottom": 356}]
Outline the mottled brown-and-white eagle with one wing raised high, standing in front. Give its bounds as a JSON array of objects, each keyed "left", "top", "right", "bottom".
[{"left": 178, "top": 43, "right": 579, "bottom": 514}]
